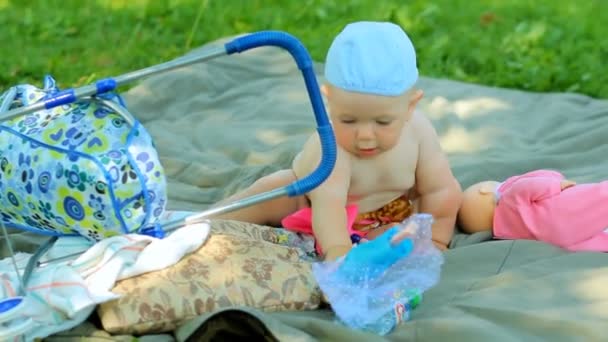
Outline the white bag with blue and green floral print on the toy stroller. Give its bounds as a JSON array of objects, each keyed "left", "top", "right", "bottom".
[{"left": 0, "top": 76, "right": 167, "bottom": 240}]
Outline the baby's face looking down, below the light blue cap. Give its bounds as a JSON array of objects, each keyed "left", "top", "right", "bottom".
[{"left": 325, "top": 86, "right": 411, "bottom": 158}]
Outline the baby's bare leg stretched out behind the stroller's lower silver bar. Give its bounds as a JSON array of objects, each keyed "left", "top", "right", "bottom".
[{"left": 213, "top": 170, "right": 308, "bottom": 226}]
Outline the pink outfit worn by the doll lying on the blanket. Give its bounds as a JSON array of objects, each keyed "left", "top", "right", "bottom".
[{"left": 493, "top": 170, "right": 608, "bottom": 252}]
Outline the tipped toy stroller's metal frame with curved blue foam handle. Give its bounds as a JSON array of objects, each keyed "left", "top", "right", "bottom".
[{"left": 0, "top": 31, "right": 337, "bottom": 338}]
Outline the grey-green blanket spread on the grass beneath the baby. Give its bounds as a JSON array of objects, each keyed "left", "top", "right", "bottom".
[{"left": 38, "top": 36, "right": 608, "bottom": 341}]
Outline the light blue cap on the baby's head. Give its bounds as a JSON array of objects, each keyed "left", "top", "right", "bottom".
[{"left": 325, "top": 21, "right": 418, "bottom": 96}]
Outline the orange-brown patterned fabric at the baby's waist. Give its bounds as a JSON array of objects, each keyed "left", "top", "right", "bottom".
[{"left": 353, "top": 195, "right": 414, "bottom": 232}]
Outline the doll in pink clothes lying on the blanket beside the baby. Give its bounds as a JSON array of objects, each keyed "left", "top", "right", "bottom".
[{"left": 457, "top": 170, "right": 608, "bottom": 252}]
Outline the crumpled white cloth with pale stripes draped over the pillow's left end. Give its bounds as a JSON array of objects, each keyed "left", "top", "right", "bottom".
[{"left": 0, "top": 215, "right": 210, "bottom": 341}]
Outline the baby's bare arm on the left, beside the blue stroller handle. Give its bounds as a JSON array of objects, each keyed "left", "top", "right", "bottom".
[{"left": 293, "top": 136, "right": 352, "bottom": 260}]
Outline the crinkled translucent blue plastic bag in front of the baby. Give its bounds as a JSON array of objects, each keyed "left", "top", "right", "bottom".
[{"left": 313, "top": 214, "right": 443, "bottom": 335}]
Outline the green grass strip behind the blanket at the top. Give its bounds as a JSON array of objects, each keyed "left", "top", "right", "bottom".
[{"left": 0, "top": 0, "right": 608, "bottom": 98}]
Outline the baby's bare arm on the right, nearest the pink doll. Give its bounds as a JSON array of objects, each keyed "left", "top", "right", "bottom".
[{"left": 414, "top": 113, "right": 462, "bottom": 250}]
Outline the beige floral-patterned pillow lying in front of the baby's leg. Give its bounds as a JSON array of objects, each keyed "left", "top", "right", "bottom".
[{"left": 98, "top": 220, "right": 321, "bottom": 334}]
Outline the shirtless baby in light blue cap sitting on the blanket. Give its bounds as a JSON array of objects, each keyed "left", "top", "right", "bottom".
[{"left": 219, "top": 22, "right": 462, "bottom": 260}]
